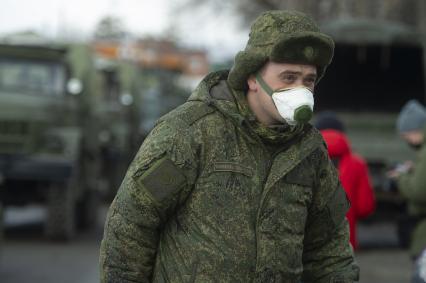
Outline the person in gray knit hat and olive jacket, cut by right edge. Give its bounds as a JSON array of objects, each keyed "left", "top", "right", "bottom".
[{"left": 388, "top": 100, "right": 426, "bottom": 283}]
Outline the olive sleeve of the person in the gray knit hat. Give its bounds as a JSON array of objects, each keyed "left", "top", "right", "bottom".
[{"left": 397, "top": 148, "right": 426, "bottom": 203}]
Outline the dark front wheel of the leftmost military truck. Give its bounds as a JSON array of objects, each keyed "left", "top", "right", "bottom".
[{"left": 45, "top": 182, "right": 75, "bottom": 241}]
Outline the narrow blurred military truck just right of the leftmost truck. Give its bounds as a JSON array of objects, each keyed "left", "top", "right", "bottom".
[{"left": 94, "top": 55, "right": 142, "bottom": 201}]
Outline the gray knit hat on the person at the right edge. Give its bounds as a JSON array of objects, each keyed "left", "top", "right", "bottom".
[{"left": 396, "top": 99, "right": 426, "bottom": 133}]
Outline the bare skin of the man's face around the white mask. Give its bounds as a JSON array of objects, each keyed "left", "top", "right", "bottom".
[{"left": 247, "top": 61, "right": 317, "bottom": 125}]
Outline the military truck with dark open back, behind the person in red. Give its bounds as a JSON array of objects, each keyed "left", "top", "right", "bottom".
[{"left": 315, "top": 19, "right": 425, "bottom": 246}]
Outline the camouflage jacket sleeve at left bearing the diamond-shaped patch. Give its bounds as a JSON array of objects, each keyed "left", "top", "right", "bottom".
[{"left": 100, "top": 122, "right": 197, "bottom": 282}]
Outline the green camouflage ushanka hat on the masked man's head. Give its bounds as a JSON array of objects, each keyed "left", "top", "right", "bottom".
[{"left": 228, "top": 11, "right": 334, "bottom": 90}]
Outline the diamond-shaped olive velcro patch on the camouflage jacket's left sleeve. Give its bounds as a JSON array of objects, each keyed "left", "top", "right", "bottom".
[{"left": 134, "top": 158, "right": 186, "bottom": 202}]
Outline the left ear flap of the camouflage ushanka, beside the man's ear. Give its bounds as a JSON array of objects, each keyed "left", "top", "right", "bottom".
[{"left": 228, "top": 51, "right": 268, "bottom": 90}]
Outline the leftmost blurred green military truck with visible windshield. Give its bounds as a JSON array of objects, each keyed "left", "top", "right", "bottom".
[{"left": 0, "top": 36, "right": 114, "bottom": 242}]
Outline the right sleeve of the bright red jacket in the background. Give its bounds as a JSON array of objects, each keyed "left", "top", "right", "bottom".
[{"left": 352, "top": 158, "right": 376, "bottom": 218}]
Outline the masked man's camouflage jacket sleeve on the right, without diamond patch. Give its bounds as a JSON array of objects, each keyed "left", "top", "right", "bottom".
[{"left": 302, "top": 148, "right": 359, "bottom": 283}]
